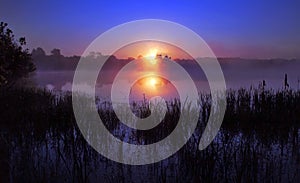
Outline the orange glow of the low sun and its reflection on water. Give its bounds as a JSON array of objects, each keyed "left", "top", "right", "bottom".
[{"left": 112, "top": 40, "right": 192, "bottom": 98}]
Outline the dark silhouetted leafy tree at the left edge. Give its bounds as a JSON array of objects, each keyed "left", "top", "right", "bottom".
[{"left": 0, "top": 22, "right": 35, "bottom": 87}]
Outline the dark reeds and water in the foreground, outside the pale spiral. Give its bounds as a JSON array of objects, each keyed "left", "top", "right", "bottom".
[{"left": 0, "top": 89, "right": 300, "bottom": 182}]
